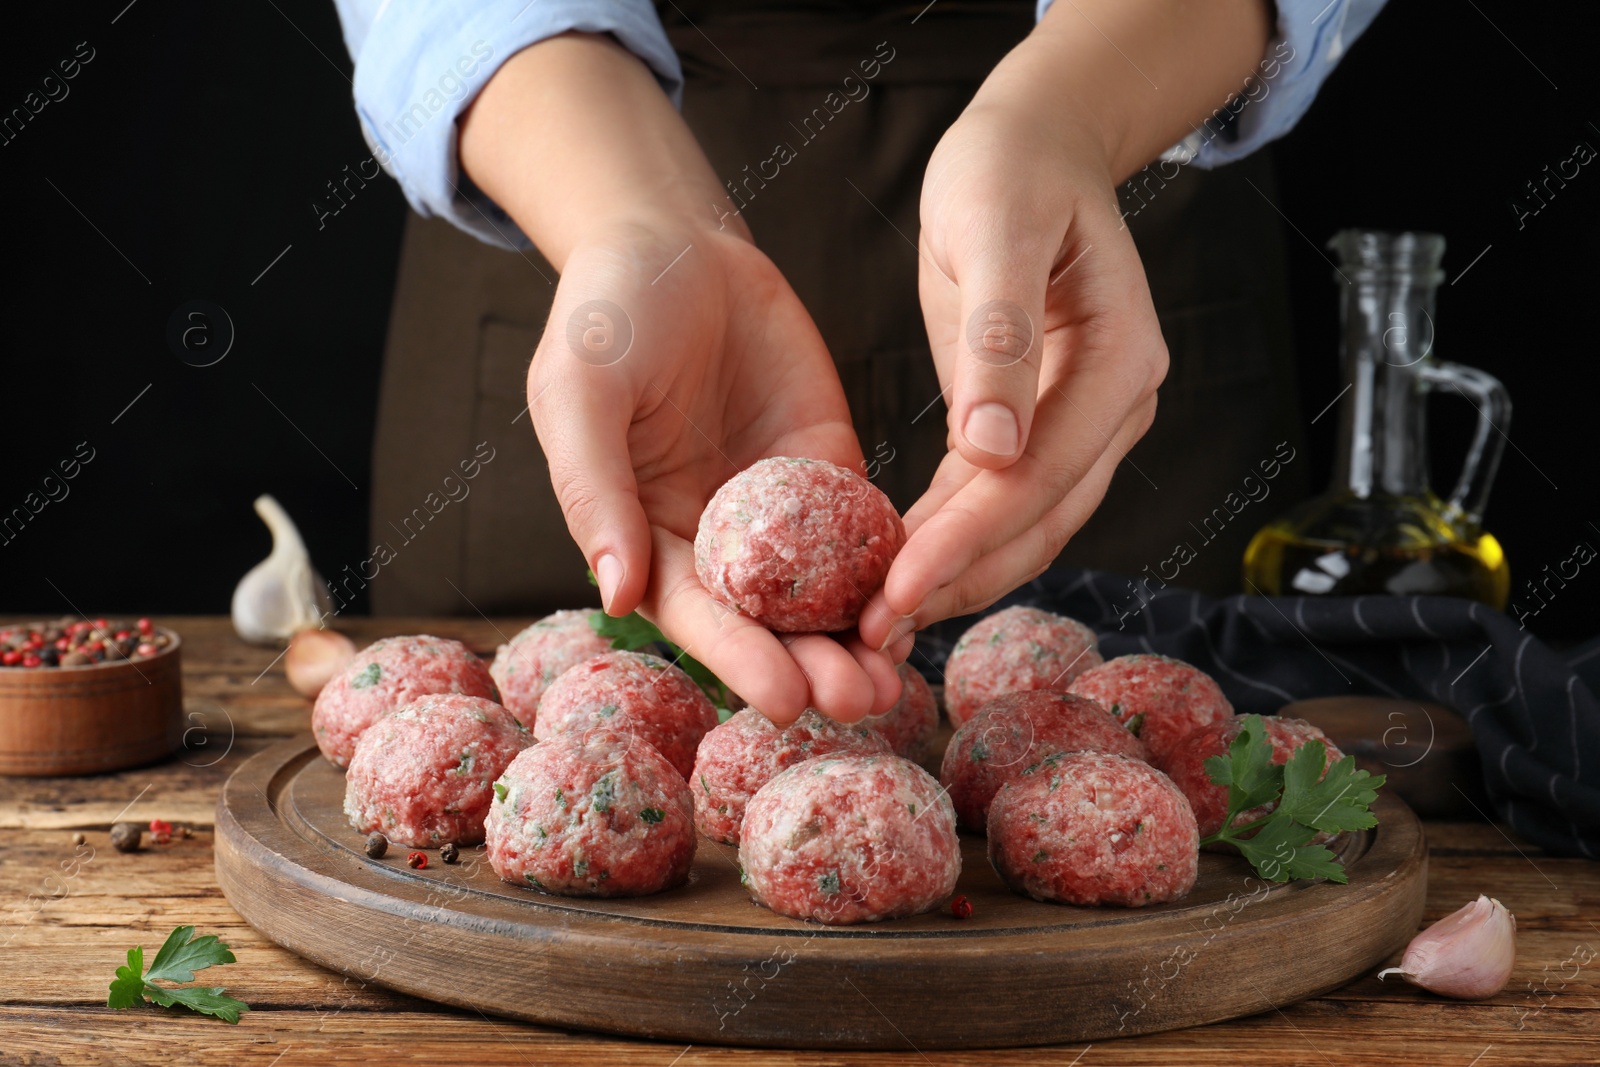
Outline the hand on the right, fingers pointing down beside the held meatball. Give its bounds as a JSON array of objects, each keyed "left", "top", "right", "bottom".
[{"left": 861, "top": 86, "right": 1166, "bottom": 648}]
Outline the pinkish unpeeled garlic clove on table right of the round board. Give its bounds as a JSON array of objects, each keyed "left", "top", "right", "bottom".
[{"left": 1378, "top": 894, "right": 1517, "bottom": 1000}]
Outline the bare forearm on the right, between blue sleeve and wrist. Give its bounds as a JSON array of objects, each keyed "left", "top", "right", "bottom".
[{"left": 974, "top": 0, "right": 1272, "bottom": 181}]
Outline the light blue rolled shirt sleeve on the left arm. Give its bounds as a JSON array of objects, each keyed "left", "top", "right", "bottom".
[{"left": 334, "top": 0, "right": 683, "bottom": 248}]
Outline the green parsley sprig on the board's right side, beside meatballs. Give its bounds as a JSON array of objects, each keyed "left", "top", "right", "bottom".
[{"left": 1200, "top": 715, "right": 1386, "bottom": 885}]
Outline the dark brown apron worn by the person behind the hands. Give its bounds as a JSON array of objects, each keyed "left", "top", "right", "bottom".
[{"left": 371, "top": 0, "right": 1306, "bottom": 614}]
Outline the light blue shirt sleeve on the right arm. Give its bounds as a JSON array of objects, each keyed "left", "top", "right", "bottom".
[{"left": 1038, "top": 0, "right": 1386, "bottom": 170}]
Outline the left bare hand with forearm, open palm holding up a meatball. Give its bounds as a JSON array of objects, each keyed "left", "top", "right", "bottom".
[{"left": 461, "top": 35, "right": 909, "bottom": 723}]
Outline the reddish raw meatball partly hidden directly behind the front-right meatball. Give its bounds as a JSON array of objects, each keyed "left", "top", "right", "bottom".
[{"left": 939, "top": 689, "right": 1150, "bottom": 833}]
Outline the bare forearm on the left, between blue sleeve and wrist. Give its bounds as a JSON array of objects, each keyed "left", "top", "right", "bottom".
[{"left": 459, "top": 34, "right": 744, "bottom": 269}]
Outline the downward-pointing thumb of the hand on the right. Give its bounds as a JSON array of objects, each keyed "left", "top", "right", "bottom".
[{"left": 950, "top": 238, "right": 1050, "bottom": 470}]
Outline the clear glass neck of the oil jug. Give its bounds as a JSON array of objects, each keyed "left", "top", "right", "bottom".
[{"left": 1334, "top": 270, "right": 1438, "bottom": 499}]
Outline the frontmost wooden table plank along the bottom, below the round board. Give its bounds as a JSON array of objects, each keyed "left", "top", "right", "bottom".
[{"left": 0, "top": 1005, "right": 1595, "bottom": 1067}]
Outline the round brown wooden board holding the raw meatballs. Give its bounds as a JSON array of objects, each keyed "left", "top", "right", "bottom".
[{"left": 216, "top": 734, "right": 1427, "bottom": 1049}]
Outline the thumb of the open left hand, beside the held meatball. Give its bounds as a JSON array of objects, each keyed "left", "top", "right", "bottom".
[{"left": 528, "top": 309, "right": 651, "bottom": 616}]
